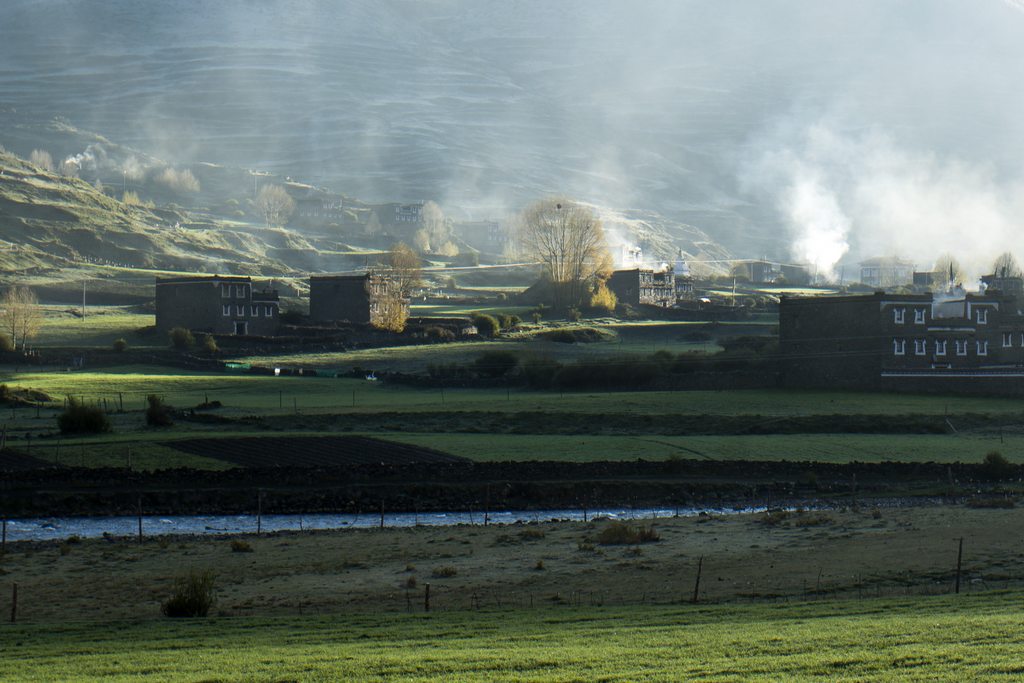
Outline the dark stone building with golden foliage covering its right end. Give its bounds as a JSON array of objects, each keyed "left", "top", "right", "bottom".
[{"left": 309, "top": 272, "right": 409, "bottom": 325}]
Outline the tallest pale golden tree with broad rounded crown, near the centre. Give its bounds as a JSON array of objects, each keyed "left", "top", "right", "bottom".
[{"left": 519, "top": 199, "right": 607, "bottom": 307}]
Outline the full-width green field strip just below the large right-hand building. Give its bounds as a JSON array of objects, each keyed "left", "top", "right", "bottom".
[{"left": 0, "top": 366, "right": 1024, "bottom": 417}]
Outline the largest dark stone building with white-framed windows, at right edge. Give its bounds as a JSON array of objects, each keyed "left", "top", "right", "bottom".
[{"left": 779, "top": 291, "right": 1024, "bottom": 393}]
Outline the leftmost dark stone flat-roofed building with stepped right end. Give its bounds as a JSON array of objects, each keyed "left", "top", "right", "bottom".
[{"left": 157, "top": 275, "right": 281, "bottom": 337}]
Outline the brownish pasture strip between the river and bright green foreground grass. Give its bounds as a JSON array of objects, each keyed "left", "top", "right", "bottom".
[{"left": 0, "top": 505, "right": 1024, "bottom": 622}]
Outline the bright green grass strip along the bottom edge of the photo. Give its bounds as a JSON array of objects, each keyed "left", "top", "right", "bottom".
[{"left": 0, "top": 593, "right": 1024, "bottom": 681}]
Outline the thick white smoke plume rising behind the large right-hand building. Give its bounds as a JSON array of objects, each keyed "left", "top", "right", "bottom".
[{"left": 743, "top": 124, "right": 1024, "bottom": 279}]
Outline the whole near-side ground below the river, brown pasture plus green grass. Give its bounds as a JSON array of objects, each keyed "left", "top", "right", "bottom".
[{"left": 0, "top": 506, "right": 1024, "bottom": 681}]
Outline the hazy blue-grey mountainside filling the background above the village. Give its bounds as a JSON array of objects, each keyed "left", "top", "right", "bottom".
[{"left": 0, "top": 0, "right": 1024, "bottom": 268}]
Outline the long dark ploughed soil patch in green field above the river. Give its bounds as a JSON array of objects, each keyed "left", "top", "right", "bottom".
[{"left": 167, "top": 436, "right": 468, "bottom": 467}]
